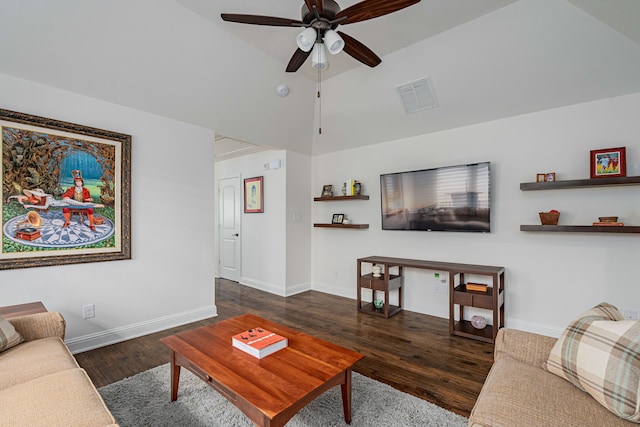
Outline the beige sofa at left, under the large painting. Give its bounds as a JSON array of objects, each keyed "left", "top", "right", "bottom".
[{"left": 0, "top": 312, "right": 117, "bottom": 427}]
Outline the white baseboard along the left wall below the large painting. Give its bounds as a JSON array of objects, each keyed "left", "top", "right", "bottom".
[{"left": 65, "top": 305, "right": 218, "bottom": 354}]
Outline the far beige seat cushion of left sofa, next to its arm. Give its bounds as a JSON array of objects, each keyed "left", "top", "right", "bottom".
[{"left": 0, "top": 338, "right": 78, "bottom": 392}]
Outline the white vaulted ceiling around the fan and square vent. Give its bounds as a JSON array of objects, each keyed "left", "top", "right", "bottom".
[{"left": 0, "top": 0, "right": 640, "bottom": 158}]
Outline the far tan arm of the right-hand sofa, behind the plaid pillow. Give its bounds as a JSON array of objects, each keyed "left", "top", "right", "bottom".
[{"left": 494, "top": 328, "right": 556, "bottom": 367}]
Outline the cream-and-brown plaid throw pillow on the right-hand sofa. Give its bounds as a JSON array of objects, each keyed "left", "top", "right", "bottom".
[{"left": 543, "top": 303, "right": 640, "bottom": 423}]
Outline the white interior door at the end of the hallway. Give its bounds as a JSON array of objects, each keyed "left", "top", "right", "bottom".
[{"left": 218, "top": 177, "right": 242, "bottom": 282}]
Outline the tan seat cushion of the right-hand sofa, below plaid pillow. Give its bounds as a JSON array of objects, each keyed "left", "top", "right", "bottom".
[{"left": 469, "top": 357, "right": 630, "bottom": 427}]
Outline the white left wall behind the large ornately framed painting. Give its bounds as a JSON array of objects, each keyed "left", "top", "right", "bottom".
[{"left": 0, "top": 75, "right": 216, "bottom": 351}]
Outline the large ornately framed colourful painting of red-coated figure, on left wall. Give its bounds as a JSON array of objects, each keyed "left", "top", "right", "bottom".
[{"left": 0, "top": 109, "right": 131, "bottom": 270}]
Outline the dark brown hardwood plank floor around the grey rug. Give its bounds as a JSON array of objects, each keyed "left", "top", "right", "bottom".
[{"left": 75, "top": 279, "right": 493, "bottom": 417}]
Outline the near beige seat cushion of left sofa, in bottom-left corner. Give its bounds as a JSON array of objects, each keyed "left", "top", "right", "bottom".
[{"left": 0, "top": 368, "right": 116, "bottom": 427}]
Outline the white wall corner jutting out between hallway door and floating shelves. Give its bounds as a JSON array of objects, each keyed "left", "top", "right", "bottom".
[{"left": 216, "top": 150, "right": 311, "bottom": 296}]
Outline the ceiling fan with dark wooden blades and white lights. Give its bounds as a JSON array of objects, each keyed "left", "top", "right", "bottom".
[{"left": 220, "top": 0, "right": 420, "bottom": 73}]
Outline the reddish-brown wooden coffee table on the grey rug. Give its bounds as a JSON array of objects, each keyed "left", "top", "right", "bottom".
[{"left": 161, "top": 314, "right": 364, "bottom": 426}]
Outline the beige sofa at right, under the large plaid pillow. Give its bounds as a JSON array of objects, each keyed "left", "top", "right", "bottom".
[{"left": 469, "top": 329, "right": 638, "bottom": 427}]
